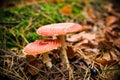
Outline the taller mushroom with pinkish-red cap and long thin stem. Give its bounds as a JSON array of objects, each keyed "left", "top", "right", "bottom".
[{"left": 37, "top": 23, "right": 83, "bottom": 77}]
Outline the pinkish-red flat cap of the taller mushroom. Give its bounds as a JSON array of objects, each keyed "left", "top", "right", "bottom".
[{"left": 37, "top": 23, "right": 83, "bottom": 36}]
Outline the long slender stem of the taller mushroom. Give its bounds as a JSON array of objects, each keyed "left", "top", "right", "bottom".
[{"left": 58, "top": 35, "right": 73, "bottom": 80}]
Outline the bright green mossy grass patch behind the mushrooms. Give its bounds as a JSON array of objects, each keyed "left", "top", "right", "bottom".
[{"left": 0, "top": 1, "right": 83, "bottom": 52}]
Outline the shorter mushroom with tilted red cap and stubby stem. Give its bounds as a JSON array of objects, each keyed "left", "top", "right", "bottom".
[{"left": 23, "top": 39, "right": 61, "bottom": 68}]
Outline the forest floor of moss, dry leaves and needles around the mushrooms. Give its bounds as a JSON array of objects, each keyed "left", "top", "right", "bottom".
[{"left": 0, "top": 0, "right": 120, "bottom": 80}]
